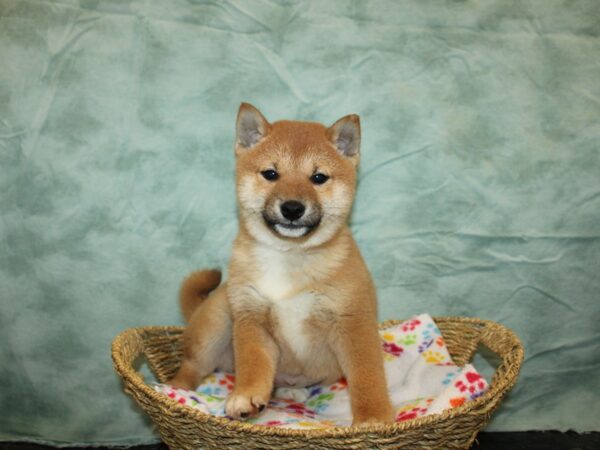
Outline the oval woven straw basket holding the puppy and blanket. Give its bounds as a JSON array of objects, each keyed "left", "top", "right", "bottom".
[{"left": 112, "top": 317, "right": 524, "bottom": 450}]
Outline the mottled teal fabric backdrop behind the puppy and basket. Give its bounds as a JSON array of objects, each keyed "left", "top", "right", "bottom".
[{"left": 0, "top": 0, "right": 600, "bottom": 444}]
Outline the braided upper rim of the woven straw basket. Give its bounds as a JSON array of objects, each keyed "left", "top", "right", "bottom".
[{"left": 111, "top": 316, "right": 524, "bottom": 438}]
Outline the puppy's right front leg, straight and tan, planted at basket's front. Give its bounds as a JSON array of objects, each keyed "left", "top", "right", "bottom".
[{"left": 331, "top": 316, "right": 394, "bottom": 425}]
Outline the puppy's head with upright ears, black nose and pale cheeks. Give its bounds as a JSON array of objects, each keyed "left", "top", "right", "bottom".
[{"left": 235, "top": 103, "right": 360, "bottom": 249}]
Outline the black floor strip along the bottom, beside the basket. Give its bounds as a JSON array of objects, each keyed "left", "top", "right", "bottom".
[{"left": 0, "top": 431, "right": 600, "bottom": 450}]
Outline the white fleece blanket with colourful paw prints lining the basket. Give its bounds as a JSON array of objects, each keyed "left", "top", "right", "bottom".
[{"left": 155, "top": 314, "right": 488, "bottom": 429}]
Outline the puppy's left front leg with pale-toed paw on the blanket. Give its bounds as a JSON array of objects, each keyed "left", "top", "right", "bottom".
[{"left": 225, "top": 318, "right": 279, "bottom": 418}]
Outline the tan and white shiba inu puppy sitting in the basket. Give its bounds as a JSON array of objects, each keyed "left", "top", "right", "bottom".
[{"left": 170, "top": 103, "right": 393, "bottom": 425}]
